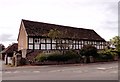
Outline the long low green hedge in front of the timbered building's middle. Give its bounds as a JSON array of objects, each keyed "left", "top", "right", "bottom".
[{"left": 35, "top": 50, "right": 80, "bottom": 62}]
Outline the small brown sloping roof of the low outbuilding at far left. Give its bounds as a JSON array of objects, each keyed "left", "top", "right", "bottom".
[{"left": 1, "top": 43, "right": 18, "bottom": 53}]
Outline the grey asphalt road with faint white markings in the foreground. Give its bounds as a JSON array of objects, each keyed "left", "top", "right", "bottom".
[{"left": 2, "top": 62, "right": 118, "bottom": 80}]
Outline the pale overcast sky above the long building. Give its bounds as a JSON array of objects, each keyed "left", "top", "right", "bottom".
[{"left": 0, "top": 0, "right": 119, "bottom": 47}]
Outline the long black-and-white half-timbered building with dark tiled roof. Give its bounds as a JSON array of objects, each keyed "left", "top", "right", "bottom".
[{"left": 18, "top": 19, "right": 105, "bottom": 60}]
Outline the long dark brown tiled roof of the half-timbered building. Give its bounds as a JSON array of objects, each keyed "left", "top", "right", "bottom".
[{"left": 22, "top": 19, "right": 105, "bottom": 41}]
